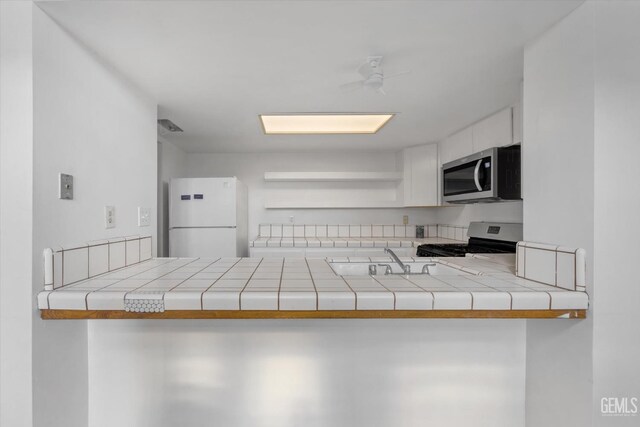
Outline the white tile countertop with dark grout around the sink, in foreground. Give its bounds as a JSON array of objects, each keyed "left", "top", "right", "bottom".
[{"left": 38, "top": 255, "right": 589, "bottom": 318}]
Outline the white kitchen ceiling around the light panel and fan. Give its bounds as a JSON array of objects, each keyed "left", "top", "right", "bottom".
[{"left": 39, "top": 0, "right": 581, "bottom": 152}]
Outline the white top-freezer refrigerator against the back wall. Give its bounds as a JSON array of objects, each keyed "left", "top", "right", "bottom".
[{"left": 169, "top": 177, "right": 249, "bottom": 258}]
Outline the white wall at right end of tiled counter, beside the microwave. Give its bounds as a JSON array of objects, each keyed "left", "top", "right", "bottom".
[{"left": 522, "top": 3, "right": 594, "bottom": 427}]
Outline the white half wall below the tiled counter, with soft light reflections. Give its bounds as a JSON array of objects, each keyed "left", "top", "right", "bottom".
[{"left": 89, "top": 319, "right": 525, "bottom": 427}]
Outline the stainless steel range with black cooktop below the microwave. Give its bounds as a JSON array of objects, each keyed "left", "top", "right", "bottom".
[{"left": 417, "top": 222, "right": 522, "bottom": 257}]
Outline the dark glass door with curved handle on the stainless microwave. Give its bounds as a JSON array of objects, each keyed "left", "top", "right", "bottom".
[{"left": 443, "top": 157, "right": 491, "bottom": 196}]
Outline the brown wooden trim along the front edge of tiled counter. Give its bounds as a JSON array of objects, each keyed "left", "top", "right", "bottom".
[{"left": 40, "top": 309, "right": 587, "bottom": 320}]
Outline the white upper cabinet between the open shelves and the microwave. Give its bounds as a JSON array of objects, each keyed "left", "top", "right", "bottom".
[{"left": 402, "top": 144, "right": 438, "bottom": 206}]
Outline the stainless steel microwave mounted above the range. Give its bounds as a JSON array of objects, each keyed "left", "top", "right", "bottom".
[{"left": 442, "top": 145, "right": 521, "bottom": 203}]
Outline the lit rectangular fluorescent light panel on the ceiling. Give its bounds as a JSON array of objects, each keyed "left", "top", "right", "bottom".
[{"left": 260, "top": 113, "right": 394, "bottom": 135}]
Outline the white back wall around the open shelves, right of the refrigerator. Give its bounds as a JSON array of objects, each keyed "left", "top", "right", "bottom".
[{"left": 182, "top": 151, "right": 435, "bottom": 237}]
